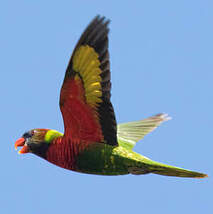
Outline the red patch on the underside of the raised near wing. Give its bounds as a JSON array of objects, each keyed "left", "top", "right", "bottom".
[{"left": 60, "top": 78, "right": 103, "bottom": 142}]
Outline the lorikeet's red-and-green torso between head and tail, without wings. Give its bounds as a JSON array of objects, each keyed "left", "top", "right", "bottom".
[{"left": 45, "top": 130, "right": 161, "bottom": 175}]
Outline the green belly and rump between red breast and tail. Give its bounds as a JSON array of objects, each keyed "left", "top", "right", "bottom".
[{"left": 77, "top": 143, "right": 143, "bottom": 175}]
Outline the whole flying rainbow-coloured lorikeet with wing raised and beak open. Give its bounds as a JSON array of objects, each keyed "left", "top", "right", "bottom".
[{"left": 15, "top": 16, "right": 207, "bottom": 178}]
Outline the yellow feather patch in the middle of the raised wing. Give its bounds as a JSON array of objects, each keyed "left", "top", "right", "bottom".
[{"left": 73, "top": 45, "right": 102, "bottom": 107}]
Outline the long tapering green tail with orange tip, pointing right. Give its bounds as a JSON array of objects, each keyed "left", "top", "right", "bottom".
[{"left": 129, "top": 158, "right": 208, "bottom": 178}]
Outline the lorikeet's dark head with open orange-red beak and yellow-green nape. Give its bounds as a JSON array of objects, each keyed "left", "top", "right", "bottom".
[{"left": 15, "top": 129, "right": 61, "bottom": 158}]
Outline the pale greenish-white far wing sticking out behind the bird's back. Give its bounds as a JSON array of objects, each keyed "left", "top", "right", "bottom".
[{"left": 117, "top": 114, "right": 171, "bottom": 149}]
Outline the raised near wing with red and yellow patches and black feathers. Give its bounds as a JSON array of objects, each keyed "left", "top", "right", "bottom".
[{"left": 60, "top": 16, "right": 118, "bottom": 146}]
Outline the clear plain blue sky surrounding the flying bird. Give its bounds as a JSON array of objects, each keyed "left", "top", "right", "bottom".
[{"left": 0, "top": 0, "right": 213, "bottom": 214}]
